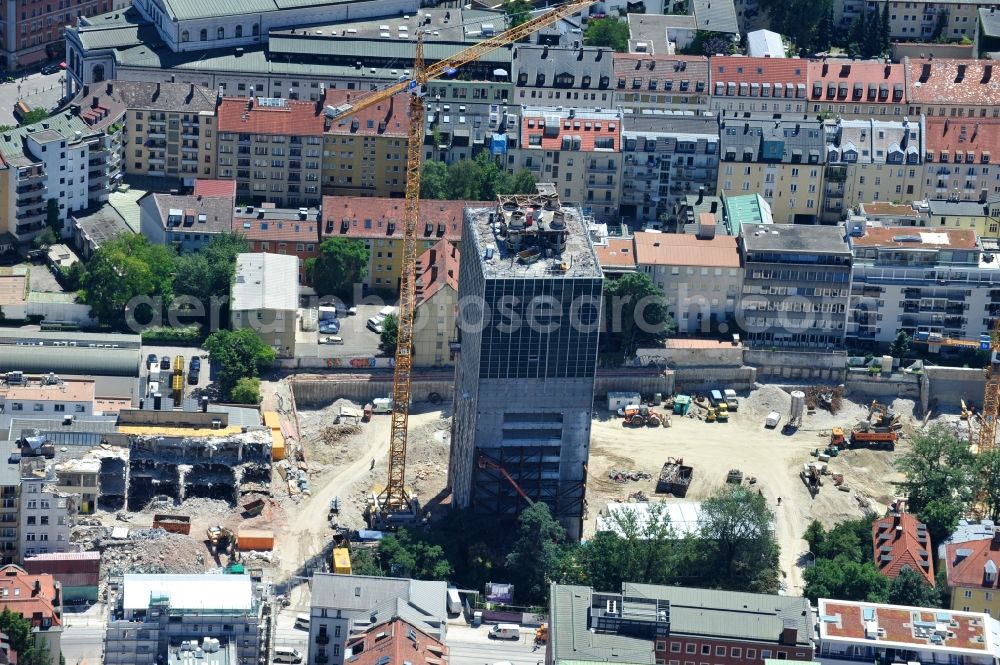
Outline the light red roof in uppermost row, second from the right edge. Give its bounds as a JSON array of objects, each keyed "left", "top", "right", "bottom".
[{"left": 808, "top": 60, "right": 905, "bottom": 104}]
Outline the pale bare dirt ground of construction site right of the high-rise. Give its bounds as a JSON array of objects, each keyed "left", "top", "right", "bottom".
[{"left": 584, "top": 386, "right": 919, "bottom": 594}]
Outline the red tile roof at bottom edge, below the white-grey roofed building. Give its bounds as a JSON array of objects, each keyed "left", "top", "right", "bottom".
[{"left": 347, "top": 618, "right": 448, "bottom": 665}]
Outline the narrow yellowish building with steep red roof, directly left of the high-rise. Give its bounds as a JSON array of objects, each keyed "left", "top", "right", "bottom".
[{"left": 413, "top": 238, "right": 461, "bottom": 367}]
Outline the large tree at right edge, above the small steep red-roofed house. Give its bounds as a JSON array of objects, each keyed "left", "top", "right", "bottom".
[{"left": 896, "top": 425, "right": 977, "bottom": 542}]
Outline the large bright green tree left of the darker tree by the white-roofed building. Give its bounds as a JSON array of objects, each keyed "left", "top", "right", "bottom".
[{"left": 80, "top": 234, "right": 177, "bottom": 328}]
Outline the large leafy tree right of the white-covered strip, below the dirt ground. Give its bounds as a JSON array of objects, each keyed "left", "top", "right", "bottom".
[{"left": 701, "top": 485, "right": 779, "bottom": 593}]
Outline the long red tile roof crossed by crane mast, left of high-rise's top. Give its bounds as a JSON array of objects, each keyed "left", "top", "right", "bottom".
[{"left": 322, "top": 196, "right": 474, "bottom": 242}]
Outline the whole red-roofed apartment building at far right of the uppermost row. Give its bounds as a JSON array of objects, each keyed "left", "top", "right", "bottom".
[{"left": 903, "top": 57, "right": 1000, "bottom": 119}]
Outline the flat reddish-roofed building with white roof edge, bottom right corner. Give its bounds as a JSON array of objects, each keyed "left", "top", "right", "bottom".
[{"left": 815, "top": 598, "right": 1000, "bottom": 665}]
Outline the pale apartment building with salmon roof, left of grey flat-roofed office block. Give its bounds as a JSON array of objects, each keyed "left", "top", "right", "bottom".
[{"left": 634, "top": 223, "right": 743, "bottom": 334}]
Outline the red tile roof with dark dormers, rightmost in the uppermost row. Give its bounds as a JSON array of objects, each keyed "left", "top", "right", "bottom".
[{"left": 903, "top": 58, "right": 1000, "bottom": 106}]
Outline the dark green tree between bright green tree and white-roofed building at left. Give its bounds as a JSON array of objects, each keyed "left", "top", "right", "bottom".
[{"left": 174, "top": 233, "right": 250, "bottom": 308}]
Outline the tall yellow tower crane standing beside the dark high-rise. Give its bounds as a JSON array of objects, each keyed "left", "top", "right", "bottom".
[{"left": 328, "top": 0, "right": 595, "bottom": 526}]
